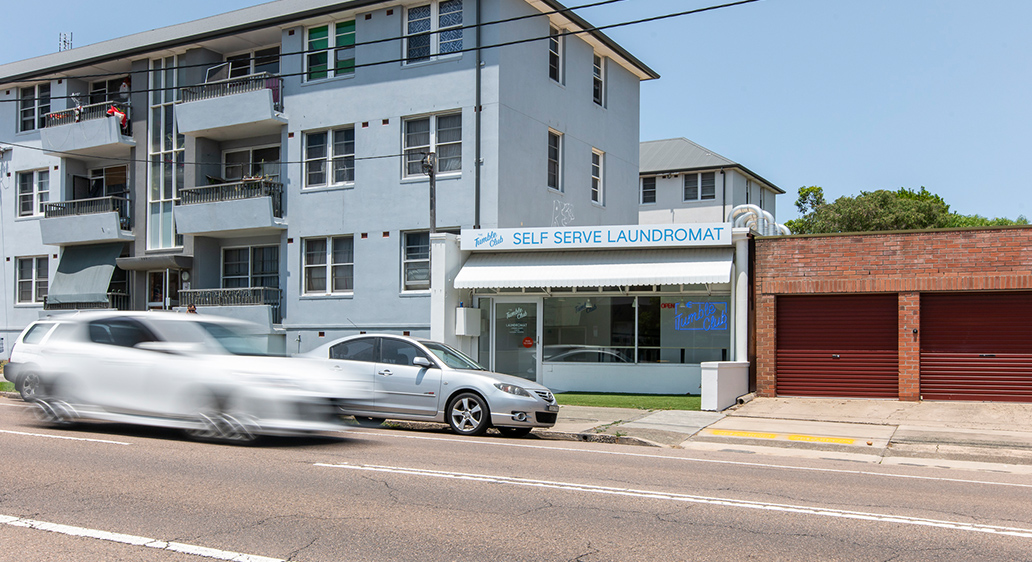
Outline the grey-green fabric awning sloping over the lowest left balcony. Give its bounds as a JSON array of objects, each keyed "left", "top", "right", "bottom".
[{"left": 46, "top": 242, "right": 125, "bottom": 304}]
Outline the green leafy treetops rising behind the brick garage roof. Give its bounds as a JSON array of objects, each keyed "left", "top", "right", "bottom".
[{"left": 785, "top": 186, "right": 1028, "bottom": 234}]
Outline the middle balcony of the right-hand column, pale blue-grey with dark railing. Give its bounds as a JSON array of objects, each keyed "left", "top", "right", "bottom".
[{"left": 175, "top": 179, "right": 287, "bottom": 237}]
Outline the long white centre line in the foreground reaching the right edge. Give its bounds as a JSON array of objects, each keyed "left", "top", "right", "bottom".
[{"left": 315, "top": 463, "right": 1032, "bottom": 538}]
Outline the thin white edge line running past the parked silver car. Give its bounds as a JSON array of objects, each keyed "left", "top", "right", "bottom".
[{"left": 361, "top": 431, "right": 1032, "bottom": 488}]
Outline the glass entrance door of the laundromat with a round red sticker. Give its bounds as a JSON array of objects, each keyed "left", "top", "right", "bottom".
[{"left": 491, "top": 299, "right": 541, "bottom": 382}]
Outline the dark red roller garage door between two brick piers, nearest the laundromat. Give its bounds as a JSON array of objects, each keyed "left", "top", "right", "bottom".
[{"left": 777, "top": 294, "right": 899, "bottom": 398}]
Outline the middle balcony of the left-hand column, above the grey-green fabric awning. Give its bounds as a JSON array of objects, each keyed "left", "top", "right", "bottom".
[{"left": 39, "top": 197, "right": 133, "bottom": 245}]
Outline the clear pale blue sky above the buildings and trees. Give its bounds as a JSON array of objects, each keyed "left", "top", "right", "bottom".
[{"left": 0, "top": 0, "right": 1032, "bottom": 221}]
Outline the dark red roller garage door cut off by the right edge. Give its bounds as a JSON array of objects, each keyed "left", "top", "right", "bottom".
[{"left": 921, "top": 293, "right": 1032, "bottom": 402}]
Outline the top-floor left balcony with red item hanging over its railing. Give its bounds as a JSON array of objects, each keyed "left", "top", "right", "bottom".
[{"left": 39, "top": 102, "right": 136, "bottom": 158}]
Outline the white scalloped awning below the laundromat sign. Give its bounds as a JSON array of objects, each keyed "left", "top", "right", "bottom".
[{"left": 455, "top": 247, "right": 734, "bottom": 289}]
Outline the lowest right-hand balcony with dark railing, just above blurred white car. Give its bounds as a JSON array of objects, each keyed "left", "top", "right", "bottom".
[{"left": 180, "top": 287, "right": 283, "bottom": 326}]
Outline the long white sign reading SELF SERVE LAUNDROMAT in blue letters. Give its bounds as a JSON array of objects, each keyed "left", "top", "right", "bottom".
[{"left": 461, "top": 223, "right": 732, "bottom": 252}]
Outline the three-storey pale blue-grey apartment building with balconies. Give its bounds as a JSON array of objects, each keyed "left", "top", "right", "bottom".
[{"left": 0, "top": 0, "right": 658, "bottom": 357}]
